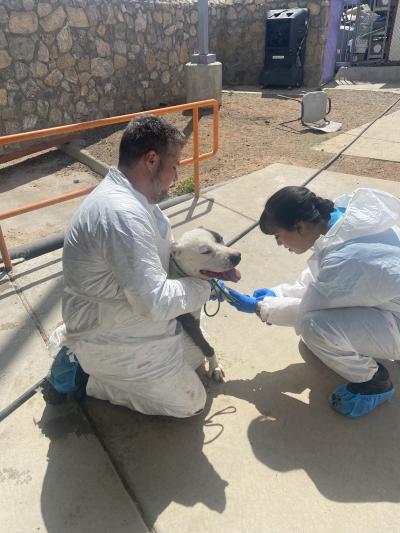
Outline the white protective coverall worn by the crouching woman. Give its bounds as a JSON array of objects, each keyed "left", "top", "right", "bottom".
[{"left": 260, "top": 189, "right": 400, "bottom": 383}]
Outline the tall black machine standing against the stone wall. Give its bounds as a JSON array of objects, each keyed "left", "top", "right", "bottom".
[{"left": 260, "top": 8, "right": 308, "bottom": 87}]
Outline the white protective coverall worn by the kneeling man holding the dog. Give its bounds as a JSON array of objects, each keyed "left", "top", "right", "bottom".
[{"left": 56, "top": 168, "right": 210, "bottom": 417}]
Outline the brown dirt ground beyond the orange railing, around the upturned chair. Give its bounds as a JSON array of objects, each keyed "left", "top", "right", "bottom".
[{"left": 82, "top": 90, "right": 400, "bottom": 191}]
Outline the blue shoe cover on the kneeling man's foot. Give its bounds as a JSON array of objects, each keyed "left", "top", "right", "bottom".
[{"left": 47, "top": 346, "right": 85, "bottom": 394}]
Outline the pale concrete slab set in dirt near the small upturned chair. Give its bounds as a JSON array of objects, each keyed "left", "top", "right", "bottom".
[{"left": 314, "top": 111, "right": 400, "bottom": 162}]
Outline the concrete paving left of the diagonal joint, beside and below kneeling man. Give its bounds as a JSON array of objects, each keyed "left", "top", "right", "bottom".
[{"left": 0, "top": 262, "right": 148, "bottom": 533}]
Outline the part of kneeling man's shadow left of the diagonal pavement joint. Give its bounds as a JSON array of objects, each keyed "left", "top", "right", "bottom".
[{"left": 36, "top": 401, "right": 147, "bottom": 533}]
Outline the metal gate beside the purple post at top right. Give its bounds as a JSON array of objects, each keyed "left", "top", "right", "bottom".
[{"left": 336, "top": 0, "right": 394, "bottom": 66}]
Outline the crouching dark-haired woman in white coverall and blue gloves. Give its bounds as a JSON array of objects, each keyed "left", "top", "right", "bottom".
[{"left": 229, "top": 187, "right": 400, "bottom": 417}]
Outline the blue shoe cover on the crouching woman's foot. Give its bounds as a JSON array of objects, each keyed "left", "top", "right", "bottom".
[{"left": 330, "top": 384, "right": 395, "bottom": 418}]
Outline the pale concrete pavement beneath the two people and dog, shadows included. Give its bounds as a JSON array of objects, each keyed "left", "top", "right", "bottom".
[{"left": 0, "top": 165, "right": 400, "bottom": 533}]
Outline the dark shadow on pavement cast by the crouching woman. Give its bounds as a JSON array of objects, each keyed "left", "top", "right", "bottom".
[{"left": 220, "top": 343, "right": 400, "bottom": 502}]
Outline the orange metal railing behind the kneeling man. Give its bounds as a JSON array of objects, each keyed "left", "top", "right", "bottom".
[{"left": 0, "top": 99, "right": 219, "bottom": 271}]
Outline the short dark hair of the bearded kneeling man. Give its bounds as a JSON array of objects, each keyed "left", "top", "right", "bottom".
[{"left": 118, "top": 115, "right": 186, "bottom": 167}]
